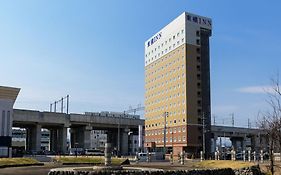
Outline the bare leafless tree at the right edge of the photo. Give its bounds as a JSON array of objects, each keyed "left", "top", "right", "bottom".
[{"left": 258, "top": 74, "right": 281, "bottom": 174}]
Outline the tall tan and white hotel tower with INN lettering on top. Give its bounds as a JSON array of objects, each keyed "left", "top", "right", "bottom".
[{"left": 145, "top": 12, "right": 212, "bottom": 155}]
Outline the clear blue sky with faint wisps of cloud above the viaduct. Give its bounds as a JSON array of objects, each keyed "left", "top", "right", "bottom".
[{"left": 0, "top": 0, "right": 281, "bottom": 126}]
